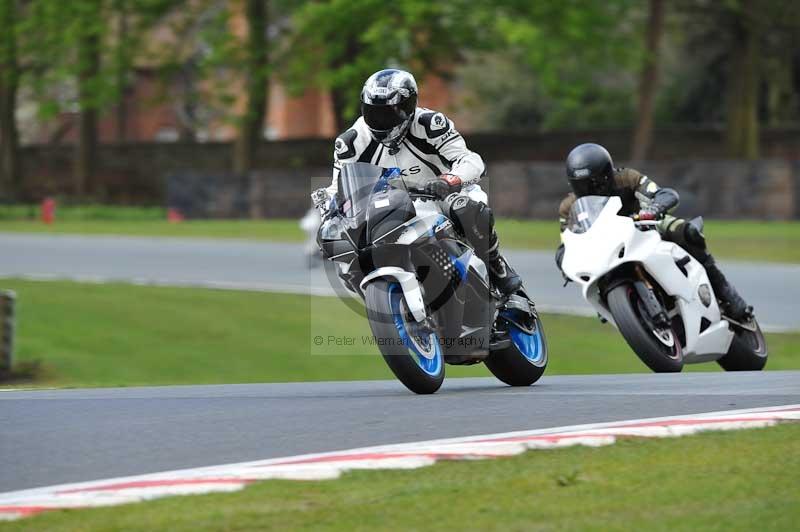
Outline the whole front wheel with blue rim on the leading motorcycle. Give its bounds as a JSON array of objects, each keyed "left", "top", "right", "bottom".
[{"left": 365, "top": 279, "right": 444, "bottom": 394}]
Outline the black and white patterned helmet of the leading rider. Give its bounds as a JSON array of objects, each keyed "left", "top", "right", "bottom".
[{"left": 361, "top": 68, "right": 417, "bottom": 148}]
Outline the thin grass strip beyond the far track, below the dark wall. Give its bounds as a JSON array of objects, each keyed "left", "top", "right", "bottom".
[{"left": 0, "top": 217, "right": 800, "bottom": 263}]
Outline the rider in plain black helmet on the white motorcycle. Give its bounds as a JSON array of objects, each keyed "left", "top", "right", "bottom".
[{"left": 556, "top": 143, "right": 753, "bottom": 321}]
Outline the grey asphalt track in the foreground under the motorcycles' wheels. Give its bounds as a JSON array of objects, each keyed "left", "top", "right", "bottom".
[{"left": 0, "top": 370, "right": 800, "bottom": 492}]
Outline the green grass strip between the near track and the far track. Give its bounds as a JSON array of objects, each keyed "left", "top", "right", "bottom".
[{"left": 0, "top": 280, "right": 800, "bottom": 386}]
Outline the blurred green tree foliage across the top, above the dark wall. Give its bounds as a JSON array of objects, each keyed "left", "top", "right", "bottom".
[{"left": 0, "top": 0, "right": 800, "bottom": 150}]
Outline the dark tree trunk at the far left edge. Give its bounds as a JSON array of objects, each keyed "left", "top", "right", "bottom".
[{"left": 0, "top": 0, "right": 22, "bottom": 197}]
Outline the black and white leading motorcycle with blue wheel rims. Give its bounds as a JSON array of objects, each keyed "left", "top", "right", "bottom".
[{"left": 318, "top": 163, "right": 548, "bottom": 394}]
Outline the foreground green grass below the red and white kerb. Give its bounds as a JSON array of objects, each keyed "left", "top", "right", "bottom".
[{"left": 0, "top": 424, "right": 800, "bottom": 532}]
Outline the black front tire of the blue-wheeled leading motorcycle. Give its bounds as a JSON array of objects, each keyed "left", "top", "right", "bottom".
[{"left": 365, "top": 279, "right": 444, "bottom": 394}]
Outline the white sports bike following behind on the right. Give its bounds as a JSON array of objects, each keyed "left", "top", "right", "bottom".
[{"left": 561, "top": 196, "right": 767, "bottom": 372}]
